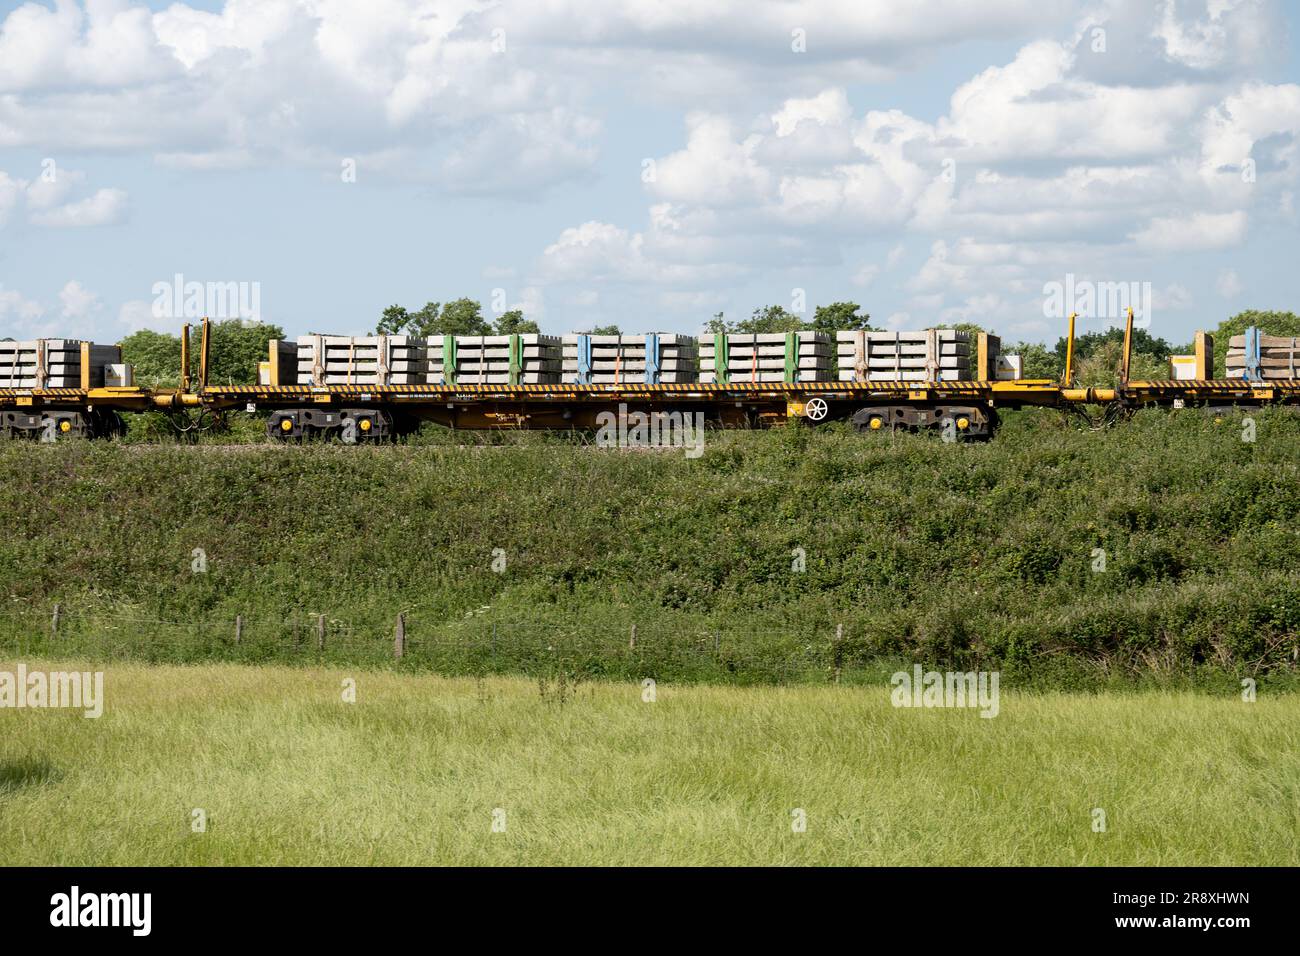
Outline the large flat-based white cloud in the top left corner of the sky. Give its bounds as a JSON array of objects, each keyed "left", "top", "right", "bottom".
[{"left": 0, "top": 0, "right": 598, "bottom": 193}]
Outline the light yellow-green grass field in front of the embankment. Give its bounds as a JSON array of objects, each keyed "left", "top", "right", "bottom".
[{"left": 0, "top": 659, "right": 1300, "bottom": 865}]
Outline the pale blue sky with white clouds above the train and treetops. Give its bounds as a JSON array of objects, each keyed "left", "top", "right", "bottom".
[{"left": 0, "top": 0, "right": 1300, "bottom": 345}]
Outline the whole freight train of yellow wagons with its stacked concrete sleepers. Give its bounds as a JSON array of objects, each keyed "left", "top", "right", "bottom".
[{"left": 0, "top": 312, "right": 1300, "bottom": 444}]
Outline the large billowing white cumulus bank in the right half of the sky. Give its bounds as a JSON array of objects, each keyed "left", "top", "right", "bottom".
[{"left": 530, "top": 5, "right": 1300, "bottom": 311}]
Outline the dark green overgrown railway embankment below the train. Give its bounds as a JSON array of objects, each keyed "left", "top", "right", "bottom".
[{"left": 0, "top": 410, "right": 1300, "bottom": 695}]
